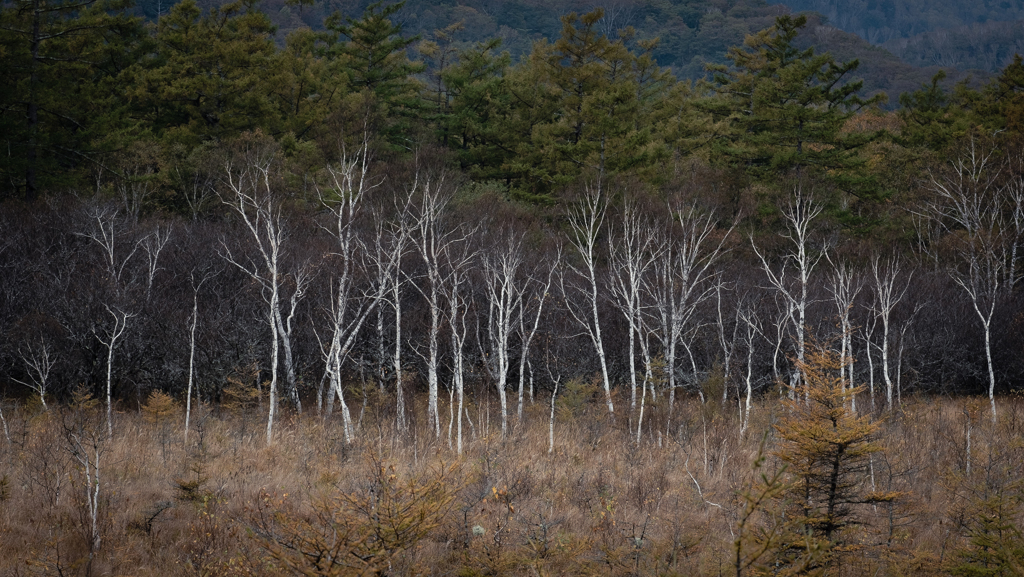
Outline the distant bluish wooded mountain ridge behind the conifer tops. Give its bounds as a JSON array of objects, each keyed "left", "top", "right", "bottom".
[{"left": 138, "top": 0, "right": 991, "bottom": 100}]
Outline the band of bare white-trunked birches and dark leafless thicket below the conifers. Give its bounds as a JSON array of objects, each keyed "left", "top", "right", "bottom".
[{"left": 0, "top": 126, "right": 1024, "bottom": 444}]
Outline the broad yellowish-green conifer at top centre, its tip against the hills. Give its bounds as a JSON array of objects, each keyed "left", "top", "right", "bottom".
[{"left": 505, "top": 8, "right": 675, "bottom": 202}]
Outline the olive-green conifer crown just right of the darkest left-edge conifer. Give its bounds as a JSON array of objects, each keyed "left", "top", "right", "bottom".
[{"left": 130, "top": 0, "right": 279, "bottom": 148}]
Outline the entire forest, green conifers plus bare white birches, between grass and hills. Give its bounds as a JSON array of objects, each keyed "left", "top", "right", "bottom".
[{"left": 6, "top": 2, "right": 1024, "bottom": 439}]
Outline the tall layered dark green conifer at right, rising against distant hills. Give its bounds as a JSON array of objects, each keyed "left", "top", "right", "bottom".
[{"left": 703, "top": 15, "right": 883, "bottom": 198}]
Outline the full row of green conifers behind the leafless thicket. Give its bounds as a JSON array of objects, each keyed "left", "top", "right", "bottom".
[{"left": 0, "top": 0, "right": 1021, "bottom": 208}]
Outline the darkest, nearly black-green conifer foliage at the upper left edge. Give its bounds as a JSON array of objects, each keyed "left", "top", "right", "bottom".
[{"left": 0, "top": 0, "right": 144, "bottom": 202}]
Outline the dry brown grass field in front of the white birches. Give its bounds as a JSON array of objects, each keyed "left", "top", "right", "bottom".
[{"left": 0, "top": 387, "right": 1024, "bottom": 576}]
